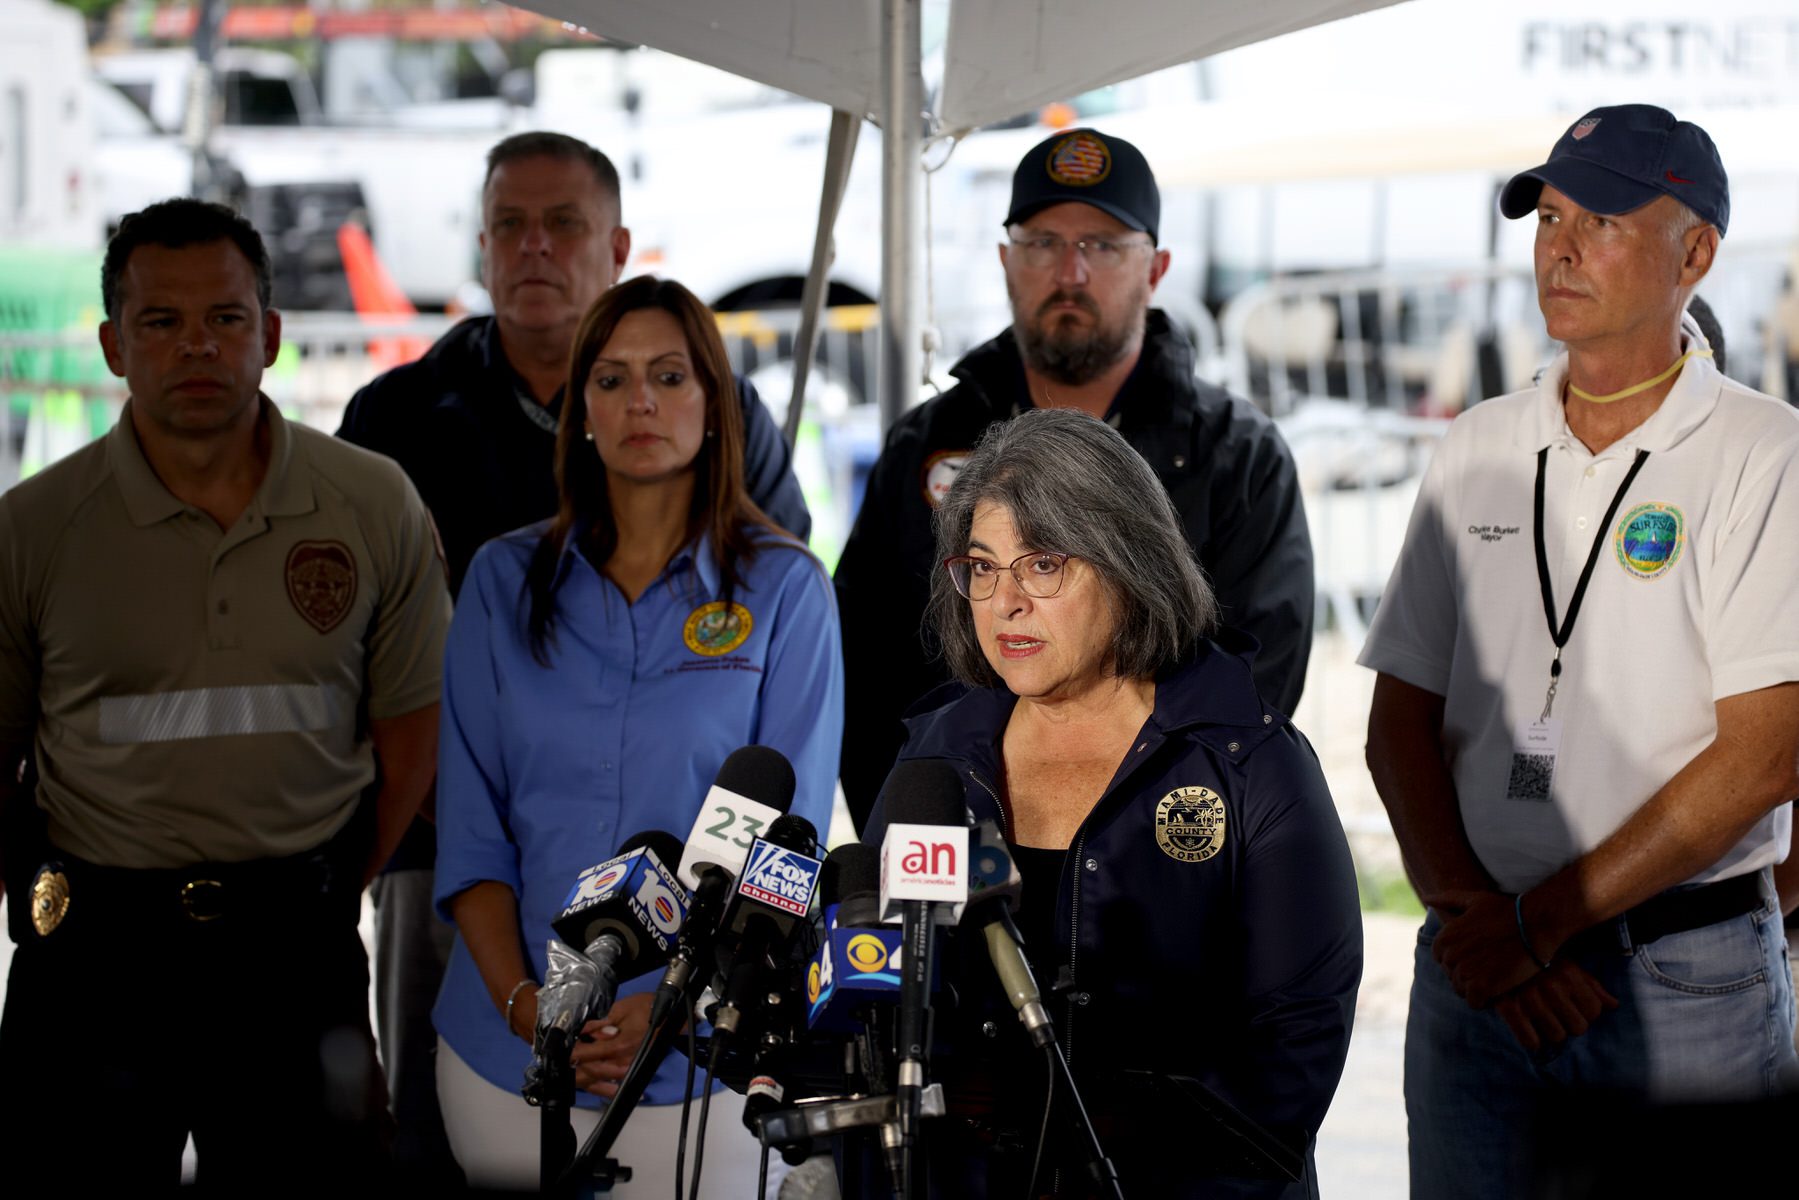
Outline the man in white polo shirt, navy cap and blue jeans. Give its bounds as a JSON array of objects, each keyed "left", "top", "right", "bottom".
[{"left": 1362, "top": 104, "right": 1799, "bottom": 1196}]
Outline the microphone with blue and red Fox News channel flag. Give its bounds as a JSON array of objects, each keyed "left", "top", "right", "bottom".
[{"left": 712, "top": 813, "right": 824, "bottom": 1051}]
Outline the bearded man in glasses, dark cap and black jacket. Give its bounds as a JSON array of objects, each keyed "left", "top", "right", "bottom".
[{"left": 837, "top": 130, "right": 1313, "bottom": 828}]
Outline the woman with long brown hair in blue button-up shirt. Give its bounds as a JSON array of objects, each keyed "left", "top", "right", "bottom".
[{"left": 434, "top": 277, "right": 844, "bottom": 1200}]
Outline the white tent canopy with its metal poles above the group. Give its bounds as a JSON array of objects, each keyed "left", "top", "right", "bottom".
[{"left": 503, "top": 0, "right": 1400, "bottom": 429}]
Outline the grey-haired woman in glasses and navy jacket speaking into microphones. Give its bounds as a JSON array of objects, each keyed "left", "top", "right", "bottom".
[{"left": 869, "top": 410, "right": 1362, "bottom": 1200}]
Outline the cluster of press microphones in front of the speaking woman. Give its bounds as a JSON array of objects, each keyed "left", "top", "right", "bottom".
[{"left": 540, "top": 747, "right": 1122, "bottom": 1200}]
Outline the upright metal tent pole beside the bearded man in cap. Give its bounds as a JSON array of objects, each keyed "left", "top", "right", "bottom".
[{"left": 880, "top": 0, "right": 925, "bottom": 430}]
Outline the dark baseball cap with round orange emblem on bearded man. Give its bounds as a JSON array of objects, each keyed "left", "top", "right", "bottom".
[{"left": 1006, "top": 130, "right": 1162, "bottom": 241}]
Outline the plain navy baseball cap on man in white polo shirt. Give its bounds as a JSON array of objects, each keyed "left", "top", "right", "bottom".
[{"left": 1499, "top": 104, "right": 1731, "bottom": 236}]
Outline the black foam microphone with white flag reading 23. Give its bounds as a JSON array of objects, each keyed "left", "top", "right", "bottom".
[{"left": 649, "top": 747, "right": 795, "bottom": 1029}]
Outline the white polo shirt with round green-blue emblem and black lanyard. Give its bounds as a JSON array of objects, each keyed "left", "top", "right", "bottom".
[{"left": 1360, "top": 356, "right": 1799, "bottom": 892}]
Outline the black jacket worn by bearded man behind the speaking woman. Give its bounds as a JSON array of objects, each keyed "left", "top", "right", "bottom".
[{"left": 837, "top": 309, "right": 1313, "bottom": 828}]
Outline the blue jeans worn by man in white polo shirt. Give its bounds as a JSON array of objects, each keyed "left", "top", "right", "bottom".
[{"left": 1405, "top": 876, "right": 1799, "bottom": 1200}]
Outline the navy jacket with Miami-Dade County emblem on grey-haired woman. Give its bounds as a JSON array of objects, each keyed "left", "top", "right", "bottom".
[{"left": 867, "top": 642, "right": 1362, "bottom": 1196}]
